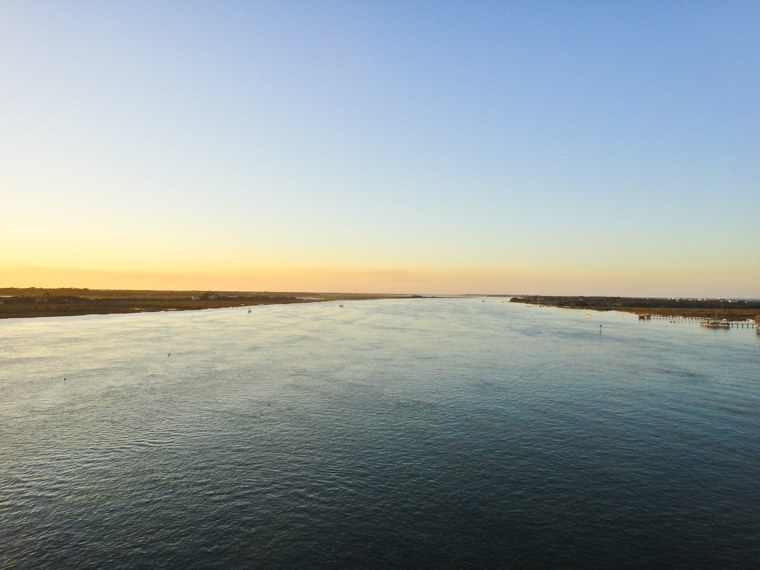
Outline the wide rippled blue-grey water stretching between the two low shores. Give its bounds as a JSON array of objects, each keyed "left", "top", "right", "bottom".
[{"left": 0, "top": 299, "right": 760, "bottom": 568}]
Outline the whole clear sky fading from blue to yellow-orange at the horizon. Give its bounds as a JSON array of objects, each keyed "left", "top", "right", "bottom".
[{"left": 0, "top": 0, "right": 760, "bottom": 298}]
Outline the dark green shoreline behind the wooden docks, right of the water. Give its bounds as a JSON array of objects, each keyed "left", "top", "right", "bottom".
[{"left": 511, "top": 295, "right": 760, "bottom": 321}]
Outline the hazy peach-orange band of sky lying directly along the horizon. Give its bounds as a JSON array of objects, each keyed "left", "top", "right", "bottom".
[{"left": 0, "top": 266, "right": 758, "bottom": 297}]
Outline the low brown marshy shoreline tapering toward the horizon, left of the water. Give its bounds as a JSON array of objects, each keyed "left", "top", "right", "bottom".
[{"left": 0, "top": 287, "right": 420, "bottom": 319}]
